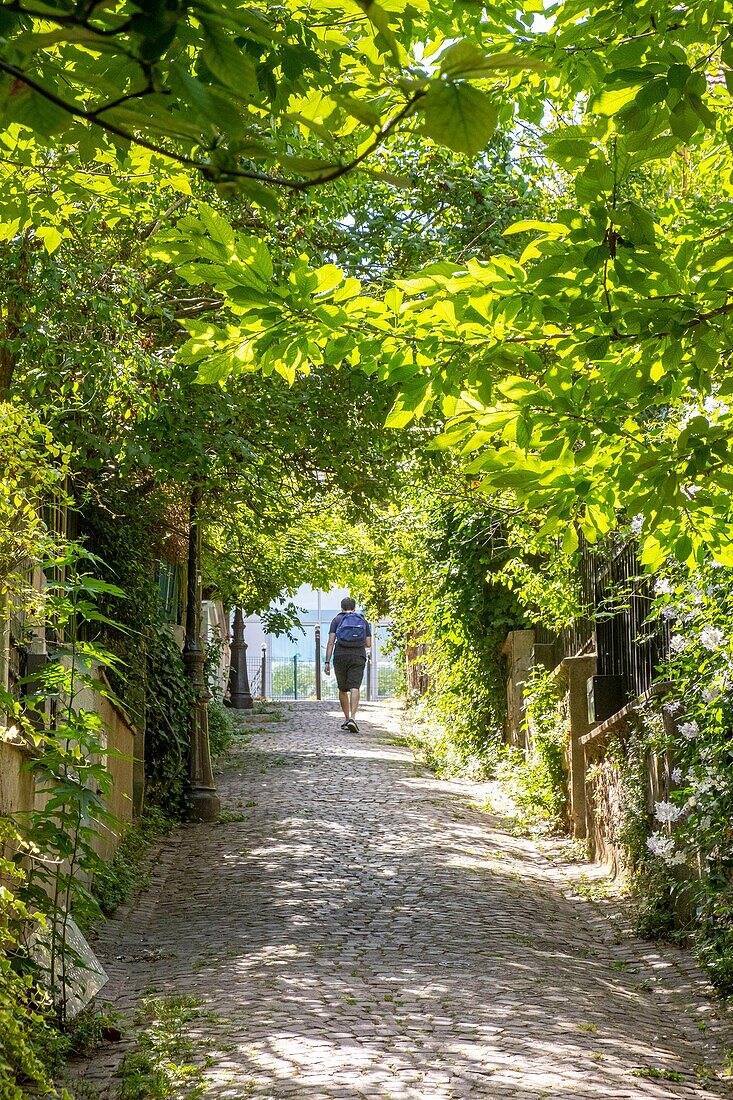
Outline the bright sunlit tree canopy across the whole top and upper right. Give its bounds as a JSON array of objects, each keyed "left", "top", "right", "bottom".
[{"left": 0, "top": 0, "right": 733, "bottom": 567}]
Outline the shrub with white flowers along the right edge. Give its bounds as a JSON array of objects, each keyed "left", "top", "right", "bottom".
[{"left": 646, "top": 562, "right": 733, "bottom": 992}]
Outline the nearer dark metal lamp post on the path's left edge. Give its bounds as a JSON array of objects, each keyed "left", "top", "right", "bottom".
[{"left": 183, "top": 487, "right": 221, "bottom": 822}]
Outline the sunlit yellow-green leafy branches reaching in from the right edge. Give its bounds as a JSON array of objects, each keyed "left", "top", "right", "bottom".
[{"left": 132, "top": 0, "right": 733, "bottom": 565}]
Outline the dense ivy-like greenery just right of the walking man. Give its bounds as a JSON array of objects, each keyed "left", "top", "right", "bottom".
[{"left": 372, "top": 471, "right": 522, "bottom": 773}]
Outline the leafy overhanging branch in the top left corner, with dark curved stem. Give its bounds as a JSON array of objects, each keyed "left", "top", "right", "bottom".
[{"left": 0, "top": 0, "right": 541, "bottom": 190}]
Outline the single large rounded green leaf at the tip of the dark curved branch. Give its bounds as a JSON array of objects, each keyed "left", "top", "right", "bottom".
[{"left": 420, "top": 81, "right": 499, "bottom": 156}]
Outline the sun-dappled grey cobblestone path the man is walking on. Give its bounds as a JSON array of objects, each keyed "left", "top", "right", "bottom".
[{"left": 75, "top": 703, "right": 733, "bottom": 1100}]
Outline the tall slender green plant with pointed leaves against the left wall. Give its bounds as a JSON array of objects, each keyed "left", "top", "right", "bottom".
[{"left": 2, "top": 554, "right": 123, "bottom": 1024}]
